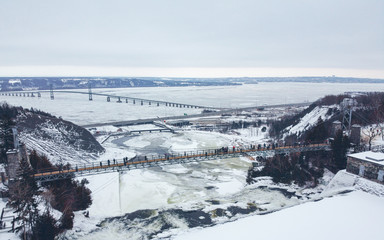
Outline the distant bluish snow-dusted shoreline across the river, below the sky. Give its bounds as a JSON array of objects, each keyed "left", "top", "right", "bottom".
[{"left": 0, "top": 76, "right": 384, "bottom": 91}]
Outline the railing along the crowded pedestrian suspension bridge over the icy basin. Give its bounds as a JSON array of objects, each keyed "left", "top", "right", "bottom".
[{"left": 33, "top": 143, "right": 329, "bottom": 178}]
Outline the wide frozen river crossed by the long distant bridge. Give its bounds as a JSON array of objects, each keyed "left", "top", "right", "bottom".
[{"left": 0, "top": 82, "right": 384, "bottom": 125}]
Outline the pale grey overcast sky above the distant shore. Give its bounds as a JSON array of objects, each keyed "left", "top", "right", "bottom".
[{"left": 0, "top": 0, "right": 384, "bottom": 78}]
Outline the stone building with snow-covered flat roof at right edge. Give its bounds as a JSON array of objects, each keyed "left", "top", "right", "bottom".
[{"left": 347, "top": 151, "right": 384, "bottom": 184}]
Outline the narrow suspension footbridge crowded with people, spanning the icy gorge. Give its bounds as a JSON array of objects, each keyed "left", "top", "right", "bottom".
[{"left": 33, "top": 144, "right": 330, "bottom": 182}]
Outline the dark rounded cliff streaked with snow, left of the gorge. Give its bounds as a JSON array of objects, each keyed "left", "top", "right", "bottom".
[{"left": 17, "top": 110, "right": 104, "bottom": 164}]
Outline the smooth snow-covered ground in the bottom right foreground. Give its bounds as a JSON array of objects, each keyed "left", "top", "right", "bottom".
[{"left": 174, "top": 171, "right": 384, "bottom": 240}]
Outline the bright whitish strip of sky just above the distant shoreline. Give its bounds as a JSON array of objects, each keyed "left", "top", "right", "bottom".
[{"left": 0, "top": 65, "right": 384, "bottom": 80}]
